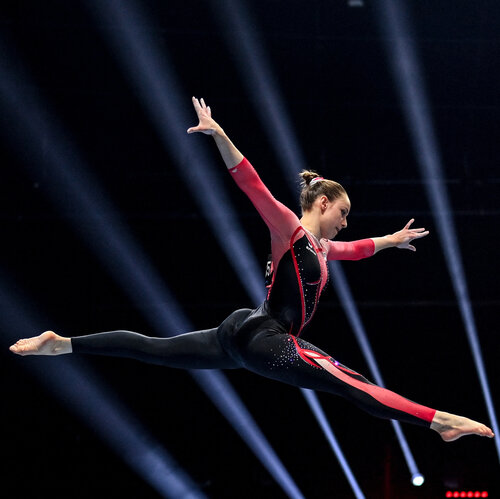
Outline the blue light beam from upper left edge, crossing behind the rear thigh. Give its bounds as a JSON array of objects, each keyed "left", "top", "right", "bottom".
[{"left": 0, "top": 36, "right": 303, "bottom": 499}]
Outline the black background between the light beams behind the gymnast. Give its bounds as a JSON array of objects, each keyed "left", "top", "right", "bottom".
[{"left": 0, "top": 0, "right": 500, "bottom": 498}]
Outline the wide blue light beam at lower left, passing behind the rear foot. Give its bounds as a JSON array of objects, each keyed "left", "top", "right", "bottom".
[{"left": 0, "top": 278, "right": 206, "bottom": 499}]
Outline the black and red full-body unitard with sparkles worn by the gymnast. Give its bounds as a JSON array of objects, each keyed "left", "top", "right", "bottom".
[{"left": 72, "top": 159, "right": 436, "bottom": 427}]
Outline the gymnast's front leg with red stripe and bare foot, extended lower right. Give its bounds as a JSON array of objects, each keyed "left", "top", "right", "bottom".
[{"left": 236, "top": 331, "right": 493, "bottom": 441}]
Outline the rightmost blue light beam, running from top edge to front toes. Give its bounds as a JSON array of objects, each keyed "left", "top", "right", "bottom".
[{"left": 377, "top": 0, "right": 500, "bottom": 460}]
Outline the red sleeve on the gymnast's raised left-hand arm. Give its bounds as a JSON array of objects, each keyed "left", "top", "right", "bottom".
[{"left": 229, "top": 158, "right": 300, "bottom": 241}]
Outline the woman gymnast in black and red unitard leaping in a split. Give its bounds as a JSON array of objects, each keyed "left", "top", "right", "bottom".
[{"left": 10, "top": 97, "right": 494, "bottom": 441}]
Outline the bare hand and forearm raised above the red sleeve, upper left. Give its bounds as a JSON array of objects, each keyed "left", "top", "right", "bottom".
[{"left": 187, "top": 97, "right": 243, "bottom": 169}]
